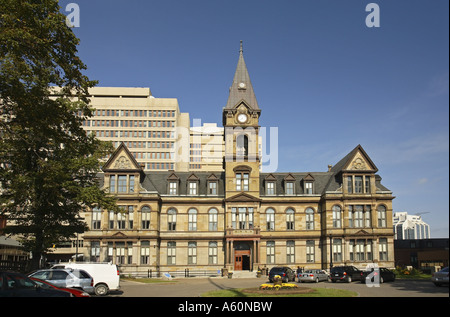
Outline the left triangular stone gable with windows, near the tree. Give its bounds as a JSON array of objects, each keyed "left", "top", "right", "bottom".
[{"left": 102, "top": 142, "right": 144, "bottom": 195}]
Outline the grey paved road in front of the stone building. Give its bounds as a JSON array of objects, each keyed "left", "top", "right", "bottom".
[{"left": 109, "top": 278, "right": 449, "bottom": 297}]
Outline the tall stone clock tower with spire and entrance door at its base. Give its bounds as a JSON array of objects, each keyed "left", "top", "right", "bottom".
[{"left": 223, "top": 41, "right": 261, "bottom": 270}]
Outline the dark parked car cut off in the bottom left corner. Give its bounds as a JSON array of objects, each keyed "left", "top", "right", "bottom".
[{"left": 0, "top": 271, "right": 73, "bottom": 297}]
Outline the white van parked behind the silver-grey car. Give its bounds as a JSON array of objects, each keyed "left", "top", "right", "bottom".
[{"left": 52, "top": 262, "right": 120, "bottom": 296}]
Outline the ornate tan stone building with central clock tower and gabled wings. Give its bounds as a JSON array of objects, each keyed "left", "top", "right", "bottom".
[{"left": 58, "top": 42, "right": 394, "bottom": 273}]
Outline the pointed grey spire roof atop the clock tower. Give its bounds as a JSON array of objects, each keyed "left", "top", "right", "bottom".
[{"left": 225, "top": 41, "right": 260, "bottom": 110}]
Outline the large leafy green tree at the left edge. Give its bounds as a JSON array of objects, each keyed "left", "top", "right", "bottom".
[{"left": 0, "top": 0, "right": 117, "bottom": 269}]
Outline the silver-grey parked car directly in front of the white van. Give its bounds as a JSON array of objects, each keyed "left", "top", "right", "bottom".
[{"left": 29, "top": 269, "right": 94, "bottom": 294}]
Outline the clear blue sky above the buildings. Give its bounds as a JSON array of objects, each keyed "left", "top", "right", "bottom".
[{"left": 60, "top": 0, "right": 449, "bottom": 237}]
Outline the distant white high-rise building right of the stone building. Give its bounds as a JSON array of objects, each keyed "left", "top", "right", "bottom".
[{"left": 393, "top": 212, "right": 431, "bottom": 240}]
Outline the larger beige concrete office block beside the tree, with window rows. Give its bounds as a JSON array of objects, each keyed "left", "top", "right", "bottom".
[{"left": 83, "top": 87, "right": 189, "bottom": 171}]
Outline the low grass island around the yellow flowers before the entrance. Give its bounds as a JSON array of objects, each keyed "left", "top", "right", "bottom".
[{"left": 201, "top": 288, "right": 358, "bottom": 297}]
